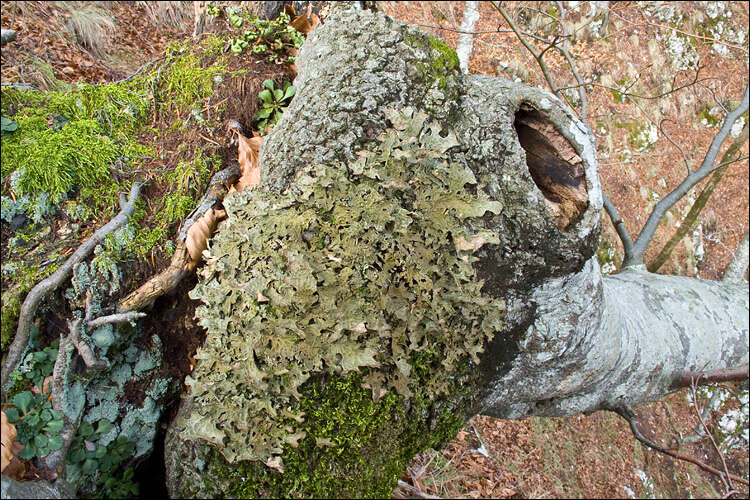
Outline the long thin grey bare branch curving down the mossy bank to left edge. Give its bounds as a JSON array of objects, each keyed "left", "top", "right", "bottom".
[{"left": 2, "top": 182, "right": 143, "bottom": 401}]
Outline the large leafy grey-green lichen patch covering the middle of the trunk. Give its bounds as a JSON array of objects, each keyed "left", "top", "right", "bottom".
[{"left": 181, "top": 108, "right": 504, "bottom": 467}]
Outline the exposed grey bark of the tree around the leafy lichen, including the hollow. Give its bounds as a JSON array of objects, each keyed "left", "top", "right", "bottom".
[{"left": 165, "top": 2, "right": 748, "bottom": 496}]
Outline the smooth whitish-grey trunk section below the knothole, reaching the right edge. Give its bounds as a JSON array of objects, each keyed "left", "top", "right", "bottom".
[{"left": 480, "top": 257, "right": 750, "bottom": 418}]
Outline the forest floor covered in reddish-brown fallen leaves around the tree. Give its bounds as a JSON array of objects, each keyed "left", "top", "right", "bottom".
[{"left": 2, "top": 2, "right": 749, "bottom": 498}]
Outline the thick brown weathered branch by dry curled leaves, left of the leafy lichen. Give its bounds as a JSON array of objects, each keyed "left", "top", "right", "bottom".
[{"left": 117, "top": 166, "right": 240, "bottom": 313}]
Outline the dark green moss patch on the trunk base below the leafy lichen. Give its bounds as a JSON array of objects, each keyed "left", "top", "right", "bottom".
[{"left": 189, "top": 368, "right": 466, "bottom": 498}]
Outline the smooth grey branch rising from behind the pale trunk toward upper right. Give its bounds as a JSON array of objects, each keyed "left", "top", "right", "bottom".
[{"left": 623, "top": 87, "right": 749, "bottom": 267}]
